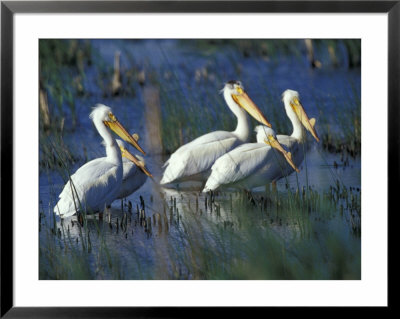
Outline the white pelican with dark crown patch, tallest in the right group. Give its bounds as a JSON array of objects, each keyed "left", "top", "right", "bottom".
[{"left": 160, "top": 81, "right": 271, "bottom": 184}]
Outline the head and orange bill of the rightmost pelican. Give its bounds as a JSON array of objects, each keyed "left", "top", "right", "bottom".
[{"left": 282, "top": 90, "right": 319, "bottom": 142}]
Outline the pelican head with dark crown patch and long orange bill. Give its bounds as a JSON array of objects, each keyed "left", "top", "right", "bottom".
[{"left": 221, "top": 81, "right": 271, "bottom": 127}]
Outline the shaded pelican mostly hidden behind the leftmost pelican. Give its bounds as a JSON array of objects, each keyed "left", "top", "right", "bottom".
[{"left": 115, "top": 139, "right": 153, "bottom": 199}]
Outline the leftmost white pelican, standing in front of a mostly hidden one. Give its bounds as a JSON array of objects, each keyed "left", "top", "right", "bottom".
[{"left": 54, "top": 104, "right": 144, "bottom": 217}]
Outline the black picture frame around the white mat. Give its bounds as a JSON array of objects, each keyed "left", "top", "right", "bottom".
[{"left": 0, "top": 0, "right": 394, "bottom": 318}]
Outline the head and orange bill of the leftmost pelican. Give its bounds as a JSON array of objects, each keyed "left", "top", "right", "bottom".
[{"left": 90, "top": 104, "right": 146, "bottom": 154}]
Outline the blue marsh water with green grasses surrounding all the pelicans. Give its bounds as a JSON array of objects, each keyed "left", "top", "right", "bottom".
[{"left": 39, "top": 39, "right": 361, "bottom": 279}]
